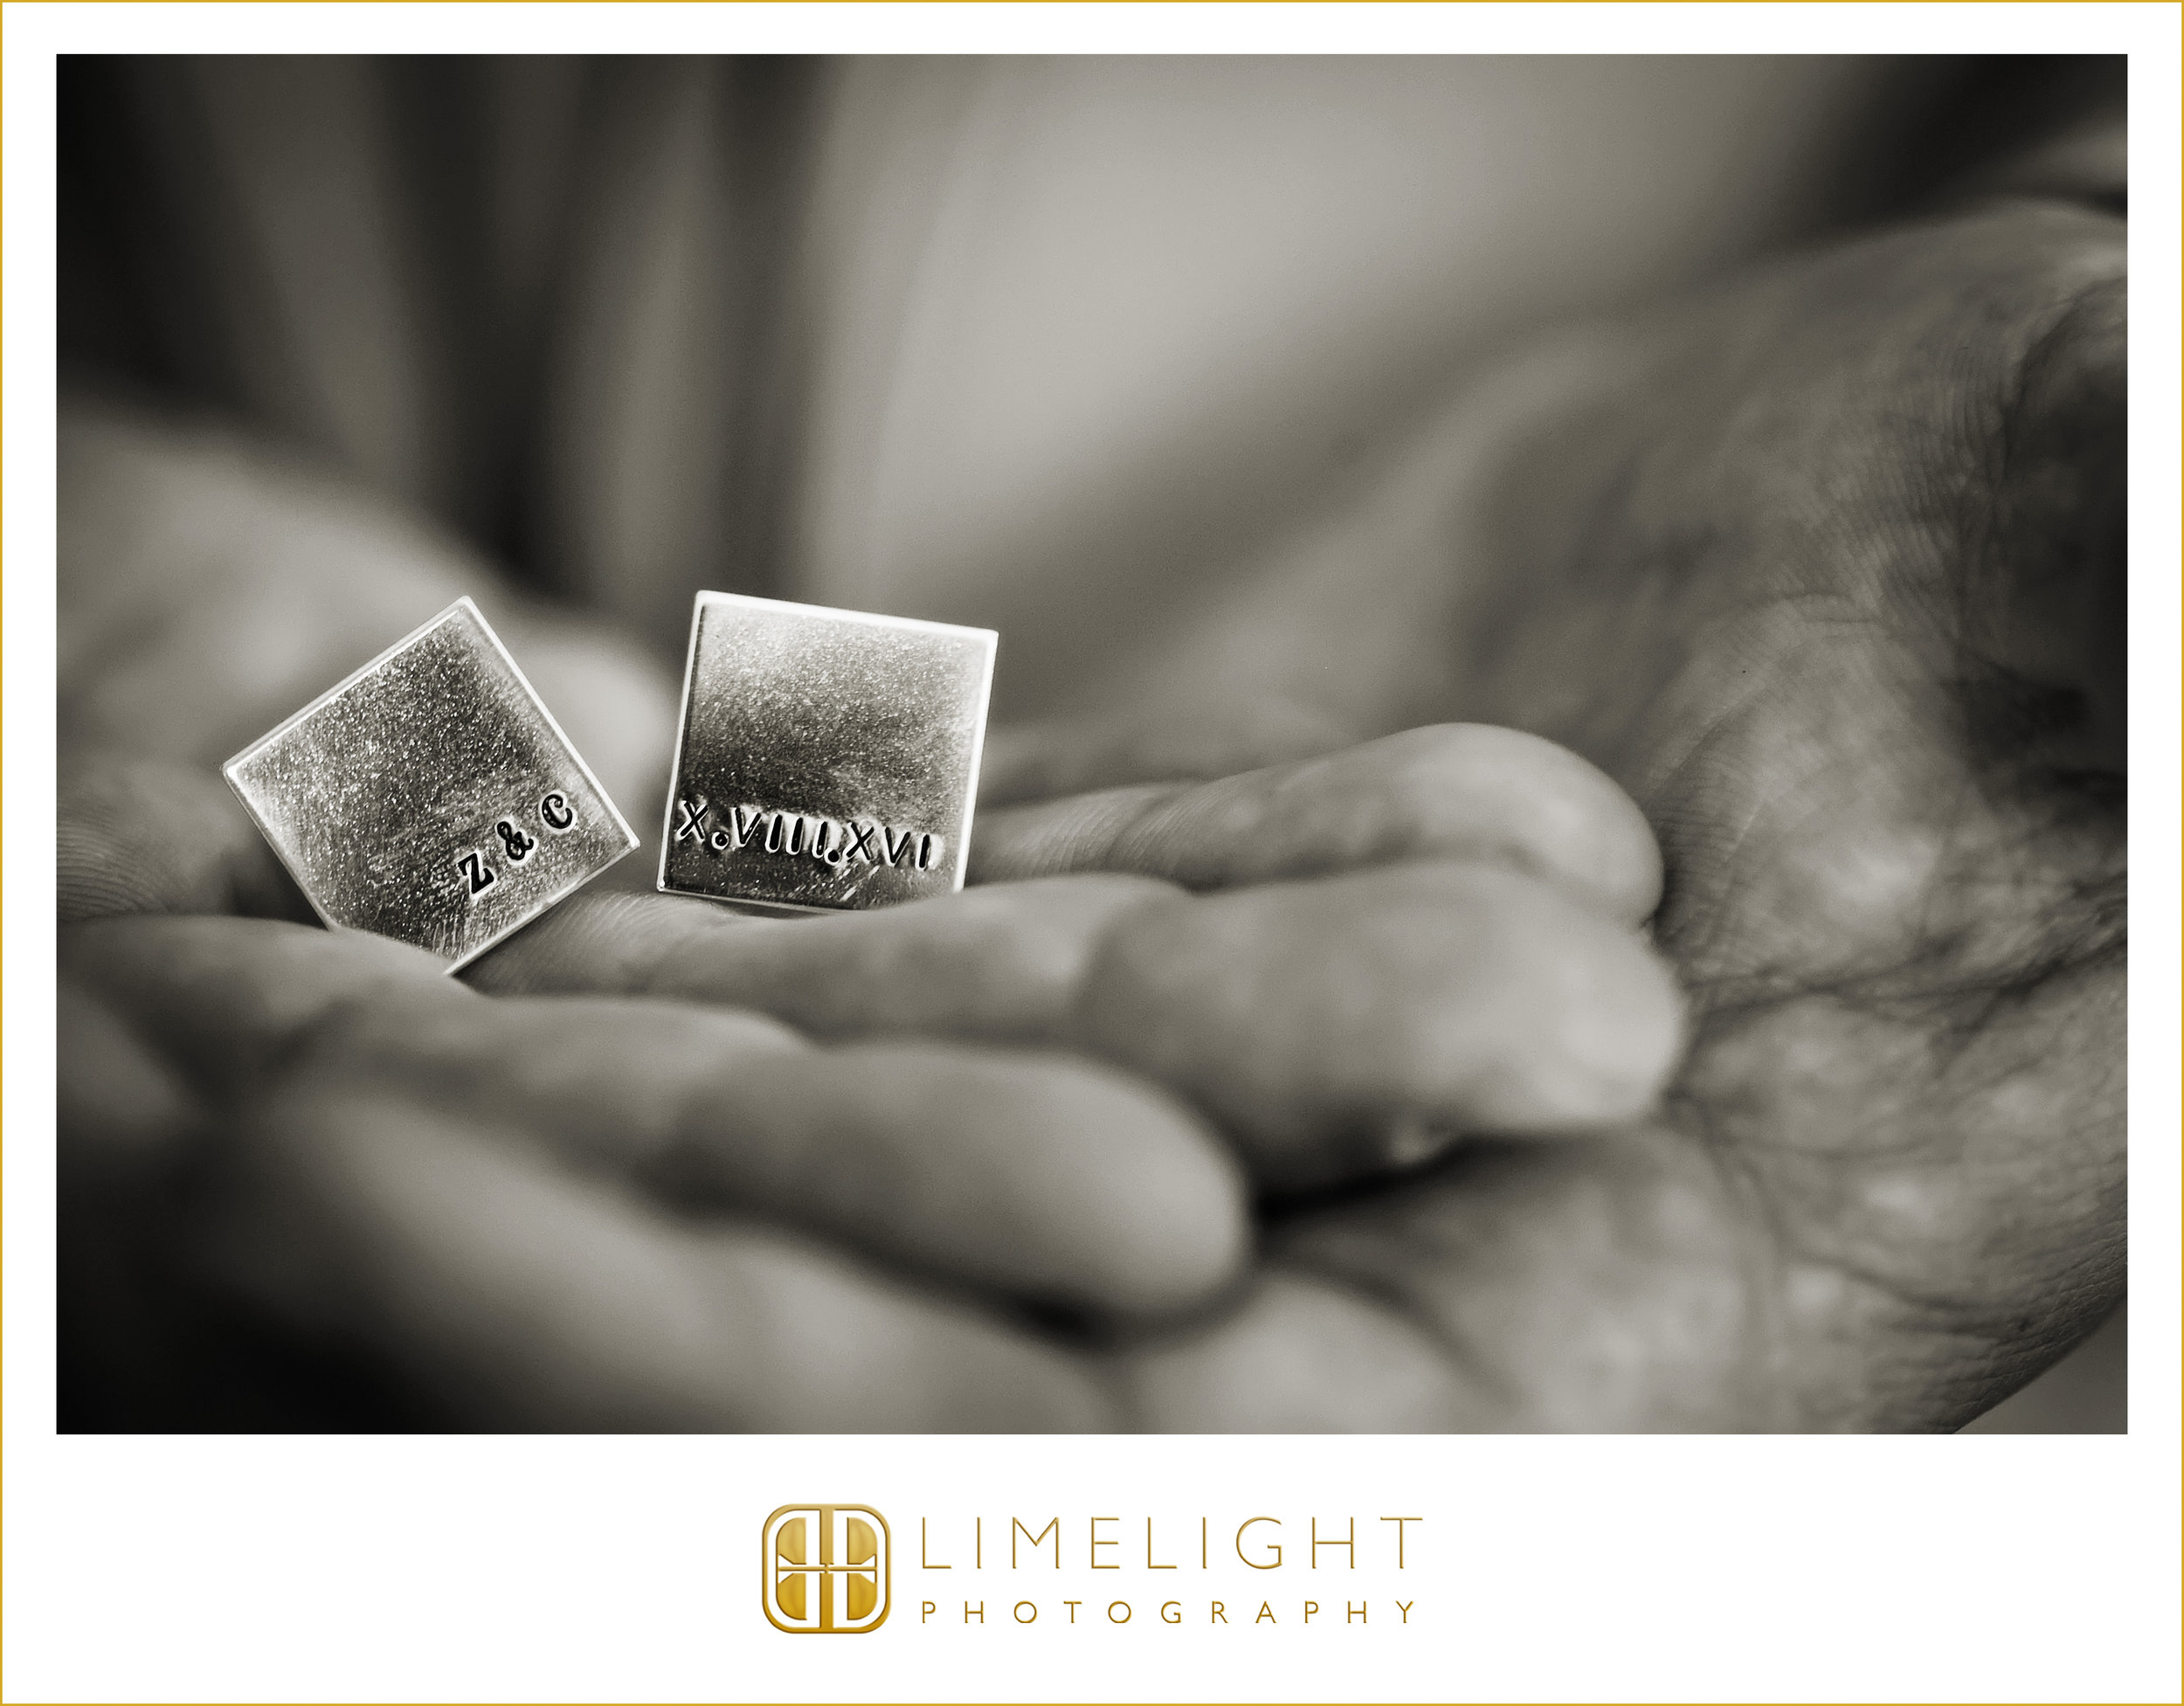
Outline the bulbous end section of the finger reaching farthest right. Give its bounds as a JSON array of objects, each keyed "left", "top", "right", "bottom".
[{"left": 1077, "top": 865, "right": 1682, "bottom": 1186}]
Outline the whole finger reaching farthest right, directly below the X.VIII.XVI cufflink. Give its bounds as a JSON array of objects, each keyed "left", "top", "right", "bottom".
[{"left": 480, "top": 865, "right": 1682, "bottom": 1184}]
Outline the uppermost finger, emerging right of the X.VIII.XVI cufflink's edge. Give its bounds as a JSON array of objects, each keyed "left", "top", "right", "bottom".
[{"left": 972, "top": 723, "right": 1660, "bottom": 924}]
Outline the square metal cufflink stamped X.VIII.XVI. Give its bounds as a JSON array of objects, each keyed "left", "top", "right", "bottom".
[{"left": 660, "top": 592, "right": 996, "bottom": 911}]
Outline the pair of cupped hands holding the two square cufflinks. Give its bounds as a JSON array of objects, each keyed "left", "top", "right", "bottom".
[{"left": 61, "top": 204, "right": 2125, "bottom": 1431}]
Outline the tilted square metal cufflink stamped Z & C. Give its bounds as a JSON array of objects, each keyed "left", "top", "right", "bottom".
[{"left": 223, "top": 598, "right": 638, "bottom": 972}]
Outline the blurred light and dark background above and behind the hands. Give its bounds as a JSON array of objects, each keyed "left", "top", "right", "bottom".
[{"left": 59, "top": 57, "right": 2123, "bottom": 1431}]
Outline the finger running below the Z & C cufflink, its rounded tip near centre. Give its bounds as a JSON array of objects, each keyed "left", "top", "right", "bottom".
[{"left": 70, "top": 920, "right": 1249, "bottom": 1313}]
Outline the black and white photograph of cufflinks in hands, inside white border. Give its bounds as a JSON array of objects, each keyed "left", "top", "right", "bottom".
[{"left": 55, "top": 38, "right": 2132, "bottom": 1441}]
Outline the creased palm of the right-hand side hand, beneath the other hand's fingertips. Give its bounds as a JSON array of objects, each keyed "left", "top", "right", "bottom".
[{"left": 1038, "top": 204, "right": 2125, "bottom": 1428}]
